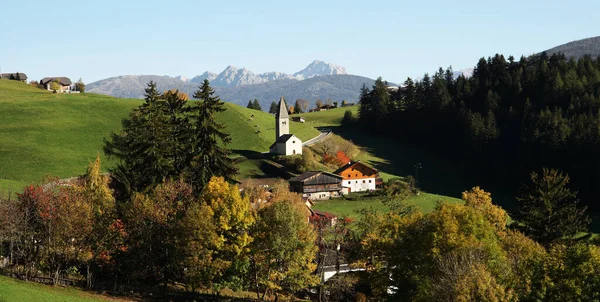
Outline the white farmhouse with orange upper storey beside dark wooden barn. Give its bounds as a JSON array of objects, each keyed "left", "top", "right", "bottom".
[{"left": 333, "top": 161, "right": 382, "bottom": 193}]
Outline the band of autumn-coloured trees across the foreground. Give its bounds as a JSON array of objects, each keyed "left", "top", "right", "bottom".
[{"left": 0, "top": 163, "right": 600, "bottom": 301}]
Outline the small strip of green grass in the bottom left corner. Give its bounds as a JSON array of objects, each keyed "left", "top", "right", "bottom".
[{"left": 0, "top": 276, "right": 125, "bottom": 302}]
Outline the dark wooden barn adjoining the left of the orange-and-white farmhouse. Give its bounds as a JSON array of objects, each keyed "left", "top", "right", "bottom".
[{"left": 289, "top": 171, "right": 342, "bottom": 200}]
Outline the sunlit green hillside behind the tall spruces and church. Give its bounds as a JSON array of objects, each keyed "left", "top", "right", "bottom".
[{"left": 0, "top": 80, "right": 319, "bottom": 191}]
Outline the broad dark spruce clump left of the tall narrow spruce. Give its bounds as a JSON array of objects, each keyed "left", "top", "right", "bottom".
[{"left": 104, "top": 82, "right": 191, "bottom": 198}]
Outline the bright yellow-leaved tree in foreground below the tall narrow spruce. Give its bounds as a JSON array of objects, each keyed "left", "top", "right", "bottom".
[{"left": 183, "top": 177, "right": 254, "bottom": 292}]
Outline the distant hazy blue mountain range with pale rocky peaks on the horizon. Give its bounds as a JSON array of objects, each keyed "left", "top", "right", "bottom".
[{"left": 86, "top": 60, "right": 374, "bottom": 108}]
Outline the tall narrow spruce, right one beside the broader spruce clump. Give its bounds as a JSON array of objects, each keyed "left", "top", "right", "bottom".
[{"left": 187, "top": 80, "right": 237, "bottom": 194}]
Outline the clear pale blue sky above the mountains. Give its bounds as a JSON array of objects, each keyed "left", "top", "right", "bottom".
[{"left": 0, "top": 0, "right": 600, "bottom": 83}]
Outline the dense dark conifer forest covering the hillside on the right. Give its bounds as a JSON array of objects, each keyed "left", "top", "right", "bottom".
[{"left": 358, "top": 53, "right": 600, "bottom": 209}]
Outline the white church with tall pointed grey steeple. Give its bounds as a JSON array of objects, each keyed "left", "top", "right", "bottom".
[{"left": 269, "top": 97, "right": 302, "bottom": 155}]
